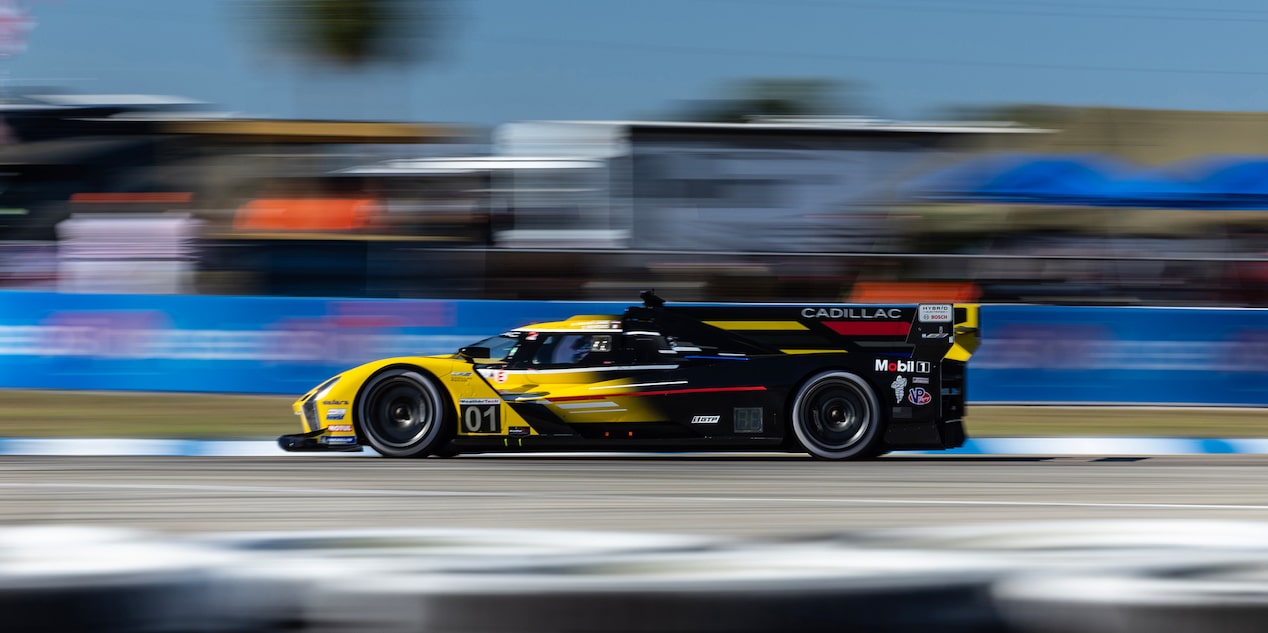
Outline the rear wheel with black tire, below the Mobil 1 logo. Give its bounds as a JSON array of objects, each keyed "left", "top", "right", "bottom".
[{"left": 791, "top": 370, "right": 884, "bottom": 459}]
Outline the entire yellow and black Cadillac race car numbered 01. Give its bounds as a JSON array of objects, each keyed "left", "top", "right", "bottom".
[{"left": 278, "top": 293, "right": 978, "bottom": 459}]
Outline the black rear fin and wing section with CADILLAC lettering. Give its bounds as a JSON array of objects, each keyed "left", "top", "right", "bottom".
[{"left": 626, "top": 303, "right": 978, "bottom": 362}]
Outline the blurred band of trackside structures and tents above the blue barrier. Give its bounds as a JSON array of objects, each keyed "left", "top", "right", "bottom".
[{"left": 0, "top": 90, "right": 1268, "bottom": 306}]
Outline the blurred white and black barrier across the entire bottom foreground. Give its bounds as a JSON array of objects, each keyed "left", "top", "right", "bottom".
[{"left": 12, "top": 520, "right": 1268, "bottom": 633}]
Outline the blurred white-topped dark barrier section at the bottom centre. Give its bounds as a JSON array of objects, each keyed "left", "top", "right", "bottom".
[{"left": 301, "top": 548, "right": 1002, "bottom": 633}]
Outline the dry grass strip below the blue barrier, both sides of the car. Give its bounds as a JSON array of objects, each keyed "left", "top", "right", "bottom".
[{"left": 0, "top": 389, "right": 1268, "bottom": 439}]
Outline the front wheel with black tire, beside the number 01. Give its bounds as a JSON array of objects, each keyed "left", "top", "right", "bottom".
[{"left": 356, "top": 368, "right": 454, "bottom": 457}]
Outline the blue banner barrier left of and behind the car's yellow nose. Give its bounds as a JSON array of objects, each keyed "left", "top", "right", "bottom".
[{"left": 0, "top": 292, "right": 626, "bottom": 395}]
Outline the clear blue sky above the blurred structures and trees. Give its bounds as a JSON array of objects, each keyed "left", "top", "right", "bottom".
[{"left": 7, "top": 0, "right": 1268, "bottom": 126}]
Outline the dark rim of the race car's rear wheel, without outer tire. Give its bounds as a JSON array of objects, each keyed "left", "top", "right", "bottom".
[{"left": 798, "top": 379, "right": 872, "bottom": 452}]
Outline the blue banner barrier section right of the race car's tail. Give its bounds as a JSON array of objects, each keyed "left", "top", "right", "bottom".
[{"left": 967, "top": 306, "right": 1268, "bottom": 406}]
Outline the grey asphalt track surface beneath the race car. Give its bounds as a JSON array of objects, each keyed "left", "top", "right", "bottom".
[{"left": 0, "top": 455, "right": 1268, "bottom": 537}]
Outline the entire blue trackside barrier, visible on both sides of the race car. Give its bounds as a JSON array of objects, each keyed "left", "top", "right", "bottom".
[{"left": 0, "top": 292, "right": 1268, "bottom": 406}]
